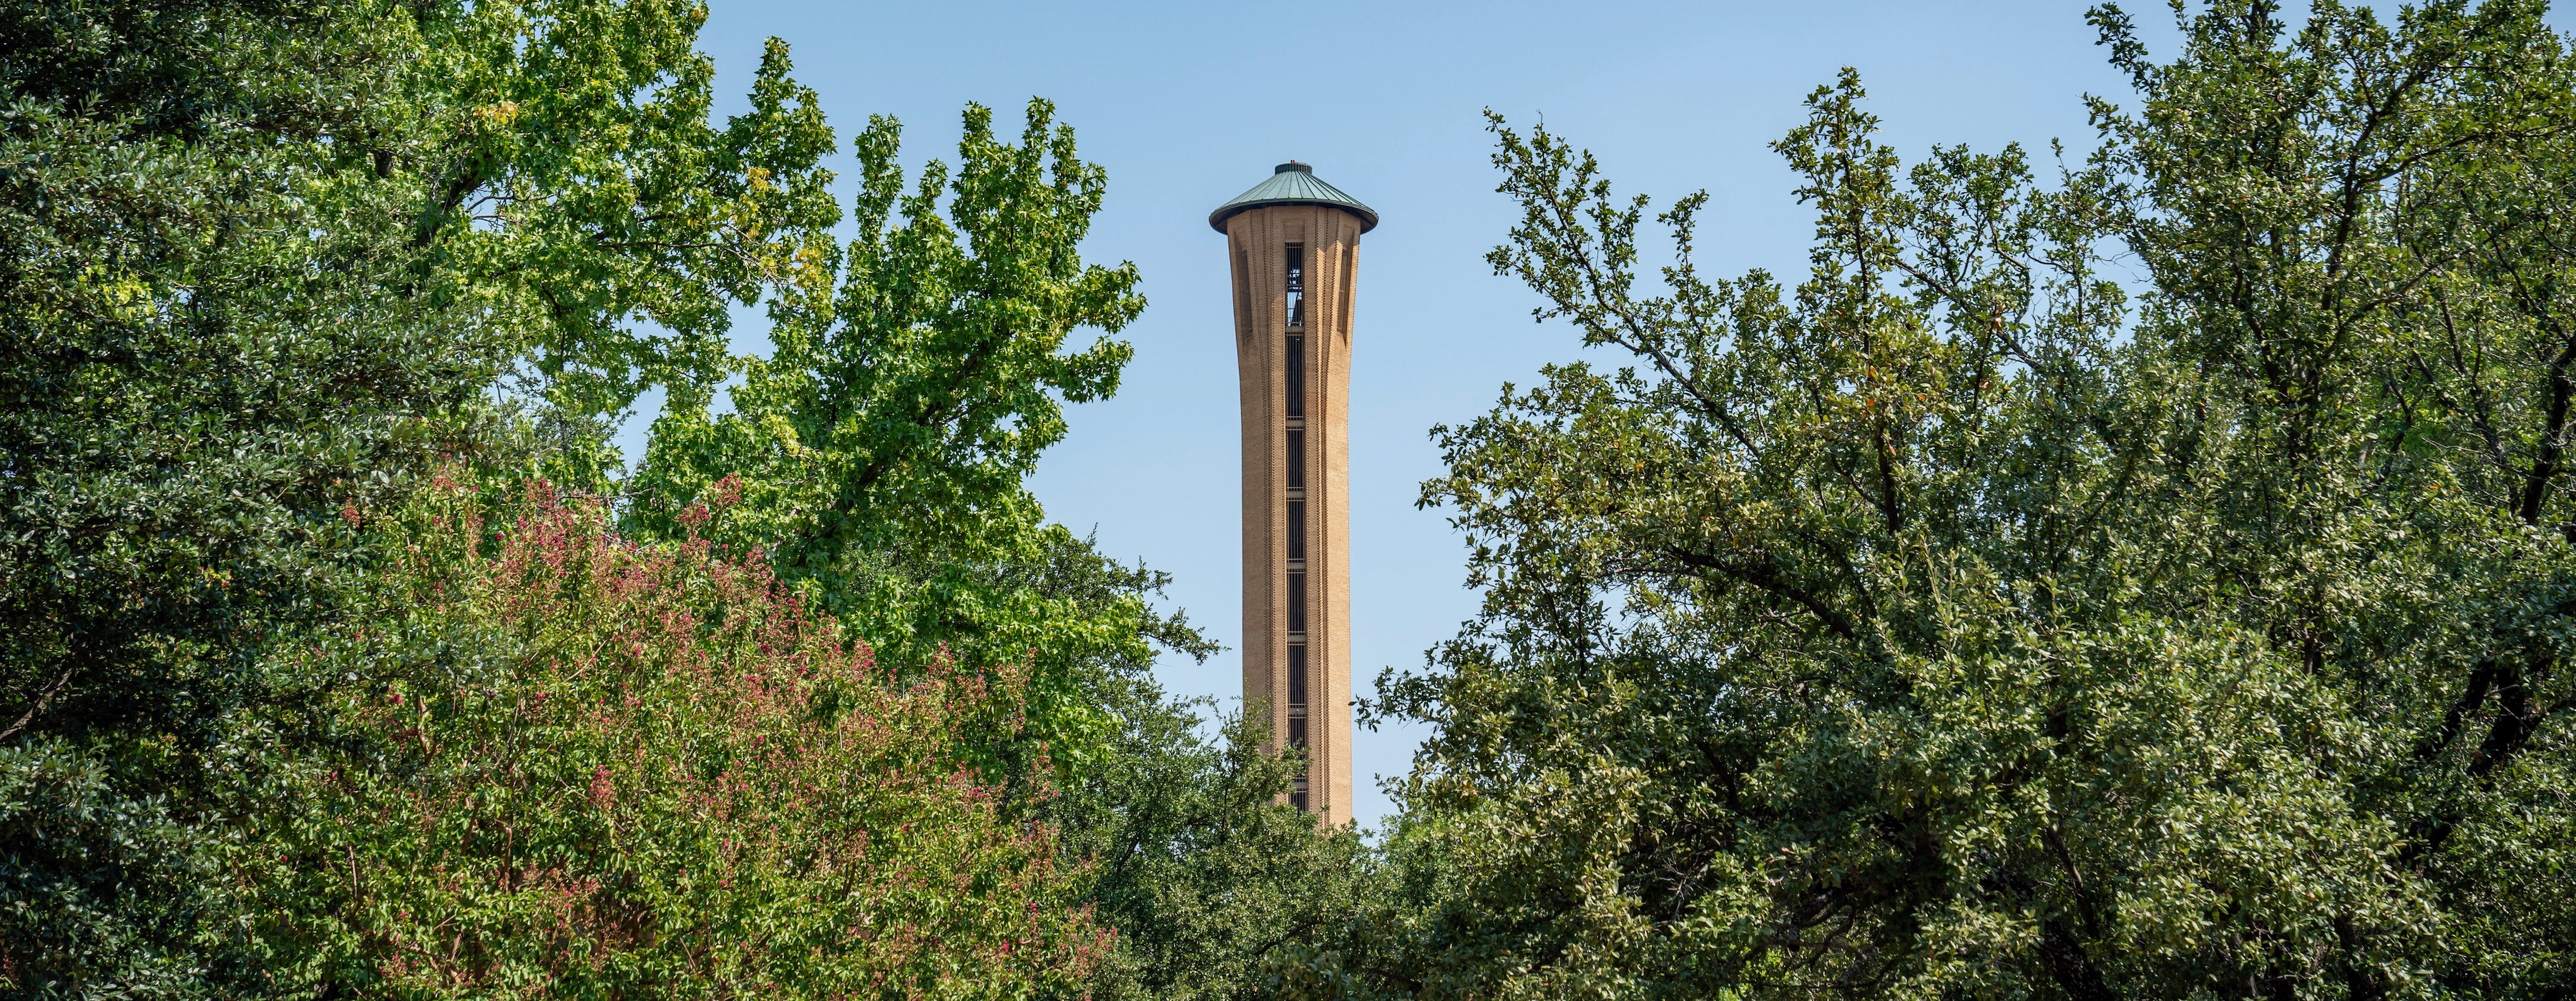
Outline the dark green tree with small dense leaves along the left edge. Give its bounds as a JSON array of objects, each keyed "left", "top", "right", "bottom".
[{"left": 0, "top": 5, "right": 469, "bottom": 996}]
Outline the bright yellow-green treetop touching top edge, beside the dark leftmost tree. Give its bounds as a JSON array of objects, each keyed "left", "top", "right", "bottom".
[{"left": 401, "top": 0, "right": 840, "bottom": 437}]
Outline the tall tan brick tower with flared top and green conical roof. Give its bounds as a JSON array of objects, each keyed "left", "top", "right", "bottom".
[{"left": 1208, "top": 159, "right": 1378, "bottom": 824}]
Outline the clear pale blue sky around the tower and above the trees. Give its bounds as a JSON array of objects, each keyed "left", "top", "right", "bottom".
[{"left": 629, "top": 0, "right": 2566, "bottom": 826}]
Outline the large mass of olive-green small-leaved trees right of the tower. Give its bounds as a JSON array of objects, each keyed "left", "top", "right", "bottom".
[{"left": 1301, "top": 0, "right": 2576, "bottom": 1001}]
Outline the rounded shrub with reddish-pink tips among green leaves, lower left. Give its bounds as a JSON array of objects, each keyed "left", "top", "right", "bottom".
[{"left": 270, "top": 486, "right": 1107, "bottom": 998}]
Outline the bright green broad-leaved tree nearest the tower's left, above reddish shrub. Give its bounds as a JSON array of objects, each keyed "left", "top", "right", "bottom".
[{"left": 629, "top": 100, "right": 1169, "bottom": 759}]
